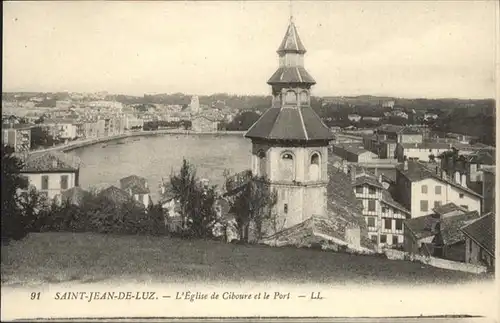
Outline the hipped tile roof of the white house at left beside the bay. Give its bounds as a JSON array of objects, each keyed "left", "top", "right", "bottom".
[{"left": 21, "top": 151, "right": 81, "bottom": 173}]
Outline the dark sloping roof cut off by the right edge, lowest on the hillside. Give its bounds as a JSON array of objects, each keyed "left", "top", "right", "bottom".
[{"left": 461, "top": 213, "right": 495, "bottom": 257}]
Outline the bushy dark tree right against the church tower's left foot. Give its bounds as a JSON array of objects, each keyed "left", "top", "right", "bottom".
[{"left": 231, "top": 176, "right": 277, "bottom": 243}]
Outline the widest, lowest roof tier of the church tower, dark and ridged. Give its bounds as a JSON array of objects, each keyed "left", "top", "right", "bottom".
[{"left": 245, "top": 107, "right": 333, "bottom": 141}]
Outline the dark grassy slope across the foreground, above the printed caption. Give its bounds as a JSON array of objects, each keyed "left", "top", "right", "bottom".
[{"left": 1, "top": 233, "right": 492, "bottom": 284}]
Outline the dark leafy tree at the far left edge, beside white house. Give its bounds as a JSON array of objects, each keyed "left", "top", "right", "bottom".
[{"left": 1, "top": 145, "right": 28, "bottom": 240}]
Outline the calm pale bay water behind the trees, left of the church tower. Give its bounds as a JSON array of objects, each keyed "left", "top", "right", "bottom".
[{"left": 68, "top": 134, "right": 251, "bottom": 202}]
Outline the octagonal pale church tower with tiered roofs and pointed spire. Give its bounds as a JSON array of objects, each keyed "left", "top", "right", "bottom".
[{"left": 245, "top": 19, "right": 333, "bottom": 231}]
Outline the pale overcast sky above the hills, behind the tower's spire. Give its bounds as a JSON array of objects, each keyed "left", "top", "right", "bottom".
[{"left": 2, "top": 1, "right": 496, "bottom": 98}]
